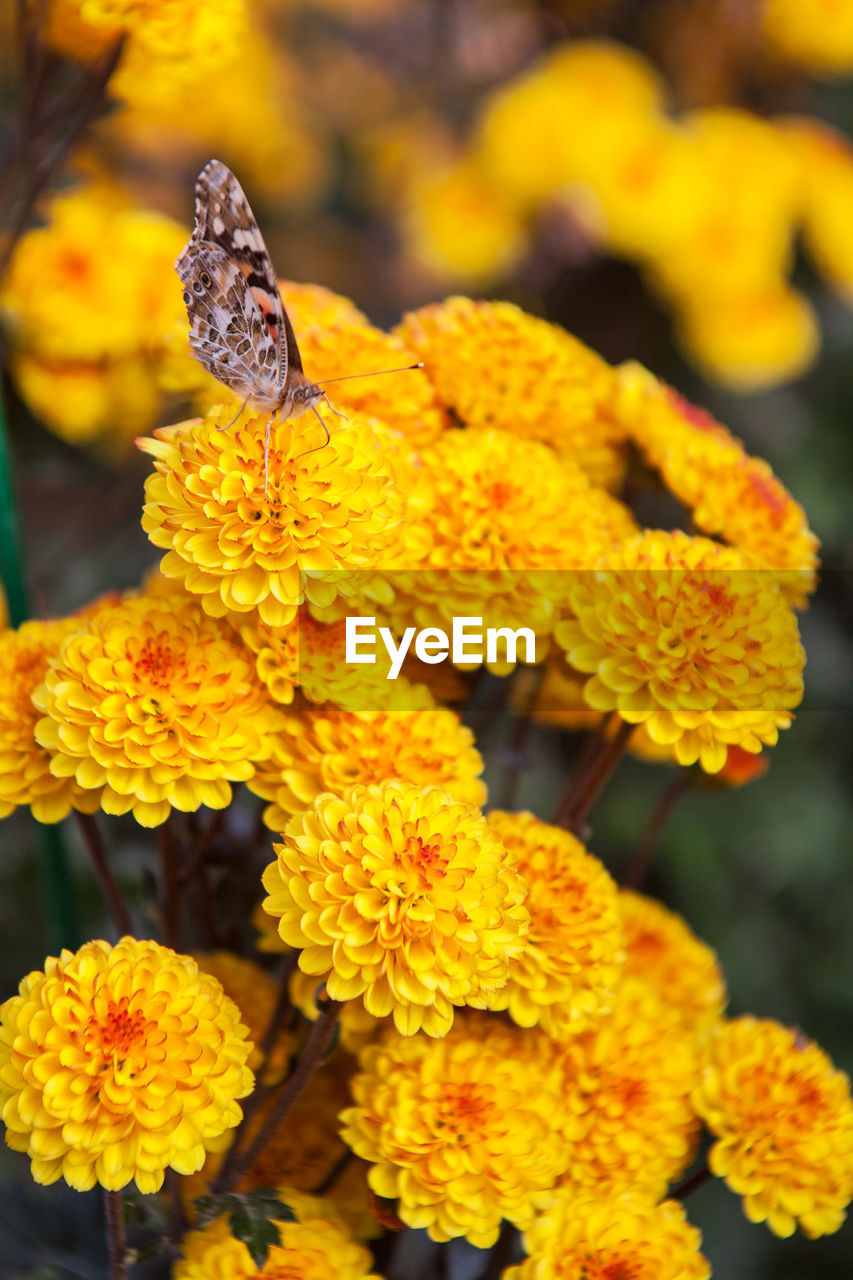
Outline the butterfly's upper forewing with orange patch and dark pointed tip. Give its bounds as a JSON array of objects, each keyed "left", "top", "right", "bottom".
[{"left": 186, "top": 160, "right": 295, "bottom": 390}]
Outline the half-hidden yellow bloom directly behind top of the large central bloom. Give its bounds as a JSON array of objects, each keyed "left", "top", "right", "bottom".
[{"left": 250, "top": 705, "right": 485, "bottom": 831}]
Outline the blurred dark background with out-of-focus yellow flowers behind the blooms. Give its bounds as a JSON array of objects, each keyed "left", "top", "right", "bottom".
[{"left": 0, "top": 0, "right": 853, "bottom": 1280}]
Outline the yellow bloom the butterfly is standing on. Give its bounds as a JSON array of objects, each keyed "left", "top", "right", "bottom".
[{"left": 140, "top": 417, "right": 403, "bottom": 627}]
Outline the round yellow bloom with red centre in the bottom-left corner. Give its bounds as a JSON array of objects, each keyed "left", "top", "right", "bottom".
[{"left": 0, "top": 938, "right": 252, "bottom": 1193}]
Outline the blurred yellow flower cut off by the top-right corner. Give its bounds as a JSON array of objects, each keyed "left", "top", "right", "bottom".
[{"left": 760, "top": 0, "right": 853, "bottom": 79}]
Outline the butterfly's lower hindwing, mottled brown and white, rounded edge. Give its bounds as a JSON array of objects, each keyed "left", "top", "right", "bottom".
[{"left": 175, "top": 239, "right": 280, "bottom": 407}]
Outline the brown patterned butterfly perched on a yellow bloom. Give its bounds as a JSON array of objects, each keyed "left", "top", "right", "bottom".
[{"left": 174, "top": 160, "right": 346, "bottom": 497}]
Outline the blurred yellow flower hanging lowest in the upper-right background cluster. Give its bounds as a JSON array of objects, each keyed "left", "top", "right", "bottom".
[{"left": 679, "top": 282, "right": 820, "bottom": 392}]
